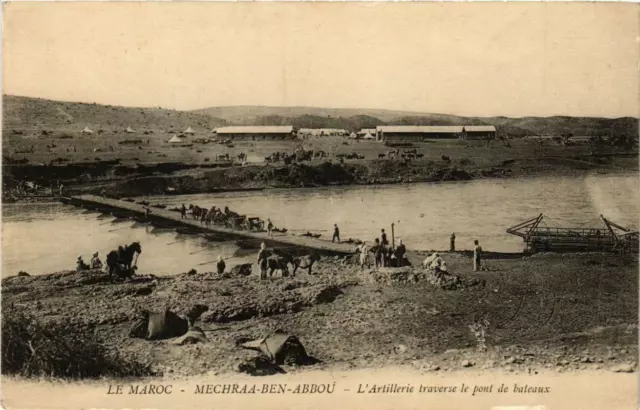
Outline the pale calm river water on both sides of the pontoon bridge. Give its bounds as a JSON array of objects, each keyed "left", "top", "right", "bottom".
[{"left": 2, "top": 174, "right": 640, "bottom": 276}]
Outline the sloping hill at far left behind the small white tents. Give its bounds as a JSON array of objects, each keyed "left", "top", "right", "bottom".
[{"left": 2, "top": 95, "right": 226, "bottom": 131}]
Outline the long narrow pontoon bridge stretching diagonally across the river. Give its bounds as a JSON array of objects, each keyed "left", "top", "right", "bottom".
[{"left": 60, "top": 195, "right": 355, "bottom": 255}]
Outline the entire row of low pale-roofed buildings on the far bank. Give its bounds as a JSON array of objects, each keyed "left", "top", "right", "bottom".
[{"left": 208, "top": 125, "right": 496, "bottom": 142}]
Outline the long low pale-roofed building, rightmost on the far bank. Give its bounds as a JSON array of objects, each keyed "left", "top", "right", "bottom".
[{"left": 376, "top": 125, "right": 496, "bottom": 142}]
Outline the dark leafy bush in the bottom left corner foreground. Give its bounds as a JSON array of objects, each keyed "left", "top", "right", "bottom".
[{"left": 2, "top": 309, "right": 153, "bottom": 379}]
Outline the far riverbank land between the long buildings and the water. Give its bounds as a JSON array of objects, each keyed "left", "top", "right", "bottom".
[{"left": 3, "top": 131, "right": 638, "bottom": 200}]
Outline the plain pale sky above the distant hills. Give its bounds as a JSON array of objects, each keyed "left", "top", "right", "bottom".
[{"left": 2, "top": 2, "right": 640, "bottom": 117}]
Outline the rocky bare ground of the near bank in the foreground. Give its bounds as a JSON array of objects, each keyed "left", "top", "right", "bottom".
[{"left": 2, "top": 254, "right": 638, "bottom": 376}]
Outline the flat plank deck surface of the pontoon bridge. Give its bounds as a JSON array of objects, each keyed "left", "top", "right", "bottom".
[{"left": 61, "top": 195, "right": 355, "bottom": 255}]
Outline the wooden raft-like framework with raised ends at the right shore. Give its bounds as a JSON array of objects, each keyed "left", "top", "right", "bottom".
[{"left": 507, "top": 214, "right": 638, "bottom": 253}]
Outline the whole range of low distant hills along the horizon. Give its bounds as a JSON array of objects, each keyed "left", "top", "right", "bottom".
[{"left": 3, "top": 96, "right": 638, "bottom": 136}]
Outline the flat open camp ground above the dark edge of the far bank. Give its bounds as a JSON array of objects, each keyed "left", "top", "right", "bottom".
[{"left": 3, "top": 130, "right": 636, "bottom": 166}]
